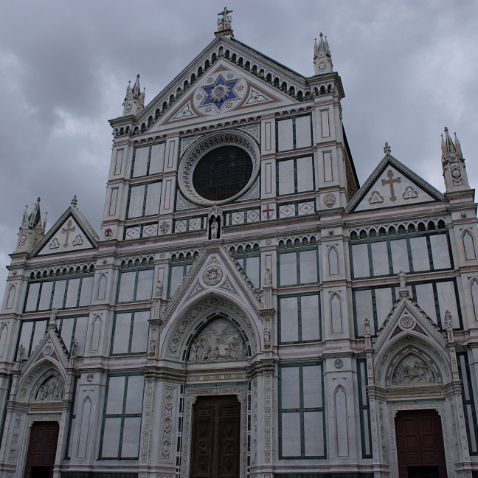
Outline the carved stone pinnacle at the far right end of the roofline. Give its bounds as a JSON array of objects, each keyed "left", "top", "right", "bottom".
[{"left": 441, "top": 127, "right": 470, "bottom": 193}]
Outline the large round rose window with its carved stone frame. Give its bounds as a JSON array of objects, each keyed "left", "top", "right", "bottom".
[{"left": 178, "top": 130, "right": 260, "bottom": 206}]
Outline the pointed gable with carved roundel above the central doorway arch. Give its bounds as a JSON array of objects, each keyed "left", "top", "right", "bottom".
[{"left": 162, "top": 246, "right": 263, "bottom": 322}]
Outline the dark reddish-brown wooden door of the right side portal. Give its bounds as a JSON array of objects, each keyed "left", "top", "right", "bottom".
[{"left": 395, "top": 410, "right": 447, "bottom": 478}]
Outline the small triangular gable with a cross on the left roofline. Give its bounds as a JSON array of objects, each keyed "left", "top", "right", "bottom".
[{"left": 32, "top": 206, "right": 98, "bottom": 256}]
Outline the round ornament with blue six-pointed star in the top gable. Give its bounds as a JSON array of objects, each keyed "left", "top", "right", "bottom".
[{"left": 193, "top": 70, "right": 247, "bottom": 115}]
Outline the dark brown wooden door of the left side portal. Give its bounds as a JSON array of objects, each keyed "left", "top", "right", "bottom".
[{"left": 24, "top": 422, "right": 59, "bottom": 478}]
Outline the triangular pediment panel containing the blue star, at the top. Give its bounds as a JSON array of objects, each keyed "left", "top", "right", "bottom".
[{"left": 151, "top": 58, "right": 296, "bottom": 132}]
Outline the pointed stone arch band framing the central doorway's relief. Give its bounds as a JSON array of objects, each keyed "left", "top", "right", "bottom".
[{"left": 160, "top": 291, "right": 260, "bottom": 360}]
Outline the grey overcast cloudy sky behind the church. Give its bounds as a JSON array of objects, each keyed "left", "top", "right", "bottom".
[{"left": 0, "top": 0, "right": 478, "bottom": 289}]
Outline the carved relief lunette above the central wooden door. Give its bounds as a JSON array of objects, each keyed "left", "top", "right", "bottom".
[{"left": 189, "top": 318, "right": 247, "bottom": 362}]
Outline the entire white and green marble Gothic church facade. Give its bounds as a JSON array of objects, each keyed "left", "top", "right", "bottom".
[{"left": 0, "top": 9, "right": 478, "bottom": 478}]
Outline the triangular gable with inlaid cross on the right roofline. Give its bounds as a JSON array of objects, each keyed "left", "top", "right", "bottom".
[{"left": 347, "top": 154, "right": 444, "bottom": 212}]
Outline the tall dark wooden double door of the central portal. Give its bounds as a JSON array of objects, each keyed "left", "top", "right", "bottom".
[{"left": 191, "top": 395, "right": 241, "bottom": 478}]
